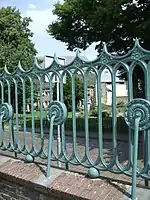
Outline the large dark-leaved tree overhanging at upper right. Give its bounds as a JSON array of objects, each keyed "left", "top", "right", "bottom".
[{"left": 47, "top": 0, "right": 150, "bottom": 96}]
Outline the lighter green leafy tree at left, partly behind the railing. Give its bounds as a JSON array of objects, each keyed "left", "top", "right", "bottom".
[{"left": 0, "top": 7, "right": 37, "bottom": 111}]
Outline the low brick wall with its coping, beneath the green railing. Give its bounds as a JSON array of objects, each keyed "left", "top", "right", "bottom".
[{"left": 0, "top": 155, "right": 136, "bottom": 200}]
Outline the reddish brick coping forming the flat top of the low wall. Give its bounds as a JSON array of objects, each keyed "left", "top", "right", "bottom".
[{"left": 0, "top": 155, "right": 149, "bottom": 200}]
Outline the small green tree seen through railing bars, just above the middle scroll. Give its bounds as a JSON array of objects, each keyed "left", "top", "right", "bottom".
[{"left": 53, "top": 76, "right": 84, "bottom": 111}]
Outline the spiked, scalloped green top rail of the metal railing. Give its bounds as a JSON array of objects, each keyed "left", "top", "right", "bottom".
[{"left": 0, "top": 38, "right": 150, "bottom": 77}]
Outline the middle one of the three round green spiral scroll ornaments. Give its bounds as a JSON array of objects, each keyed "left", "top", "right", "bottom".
[{"left": 46, "top": 101, "right": 68, "bottom": 125}]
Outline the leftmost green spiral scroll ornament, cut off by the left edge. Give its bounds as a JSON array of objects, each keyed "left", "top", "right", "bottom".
[{"left": 0, "top": 103, "right": 13, "bottom": 122}]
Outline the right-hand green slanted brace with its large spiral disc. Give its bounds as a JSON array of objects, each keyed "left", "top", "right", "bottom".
[{"left": 124, "top": 98, "right": 150, "bottom": 200}]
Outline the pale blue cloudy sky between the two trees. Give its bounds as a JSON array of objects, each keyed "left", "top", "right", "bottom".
[{"left": 0, "top": 0, "right": 97, "bottom": 60}]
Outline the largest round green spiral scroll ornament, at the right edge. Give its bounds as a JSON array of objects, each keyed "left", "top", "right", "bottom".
[{"left": 124, "top": 98, "right": 150, "bottom": 131}]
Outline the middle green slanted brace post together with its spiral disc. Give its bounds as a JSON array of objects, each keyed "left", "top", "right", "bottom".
[{"left": 46, "top": 101, "right": 68, "bottom": 178}]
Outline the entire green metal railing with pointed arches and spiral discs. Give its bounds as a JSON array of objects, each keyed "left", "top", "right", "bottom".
[{"left": 0, "top": 40, "right": 150, "bottom": 200}]
